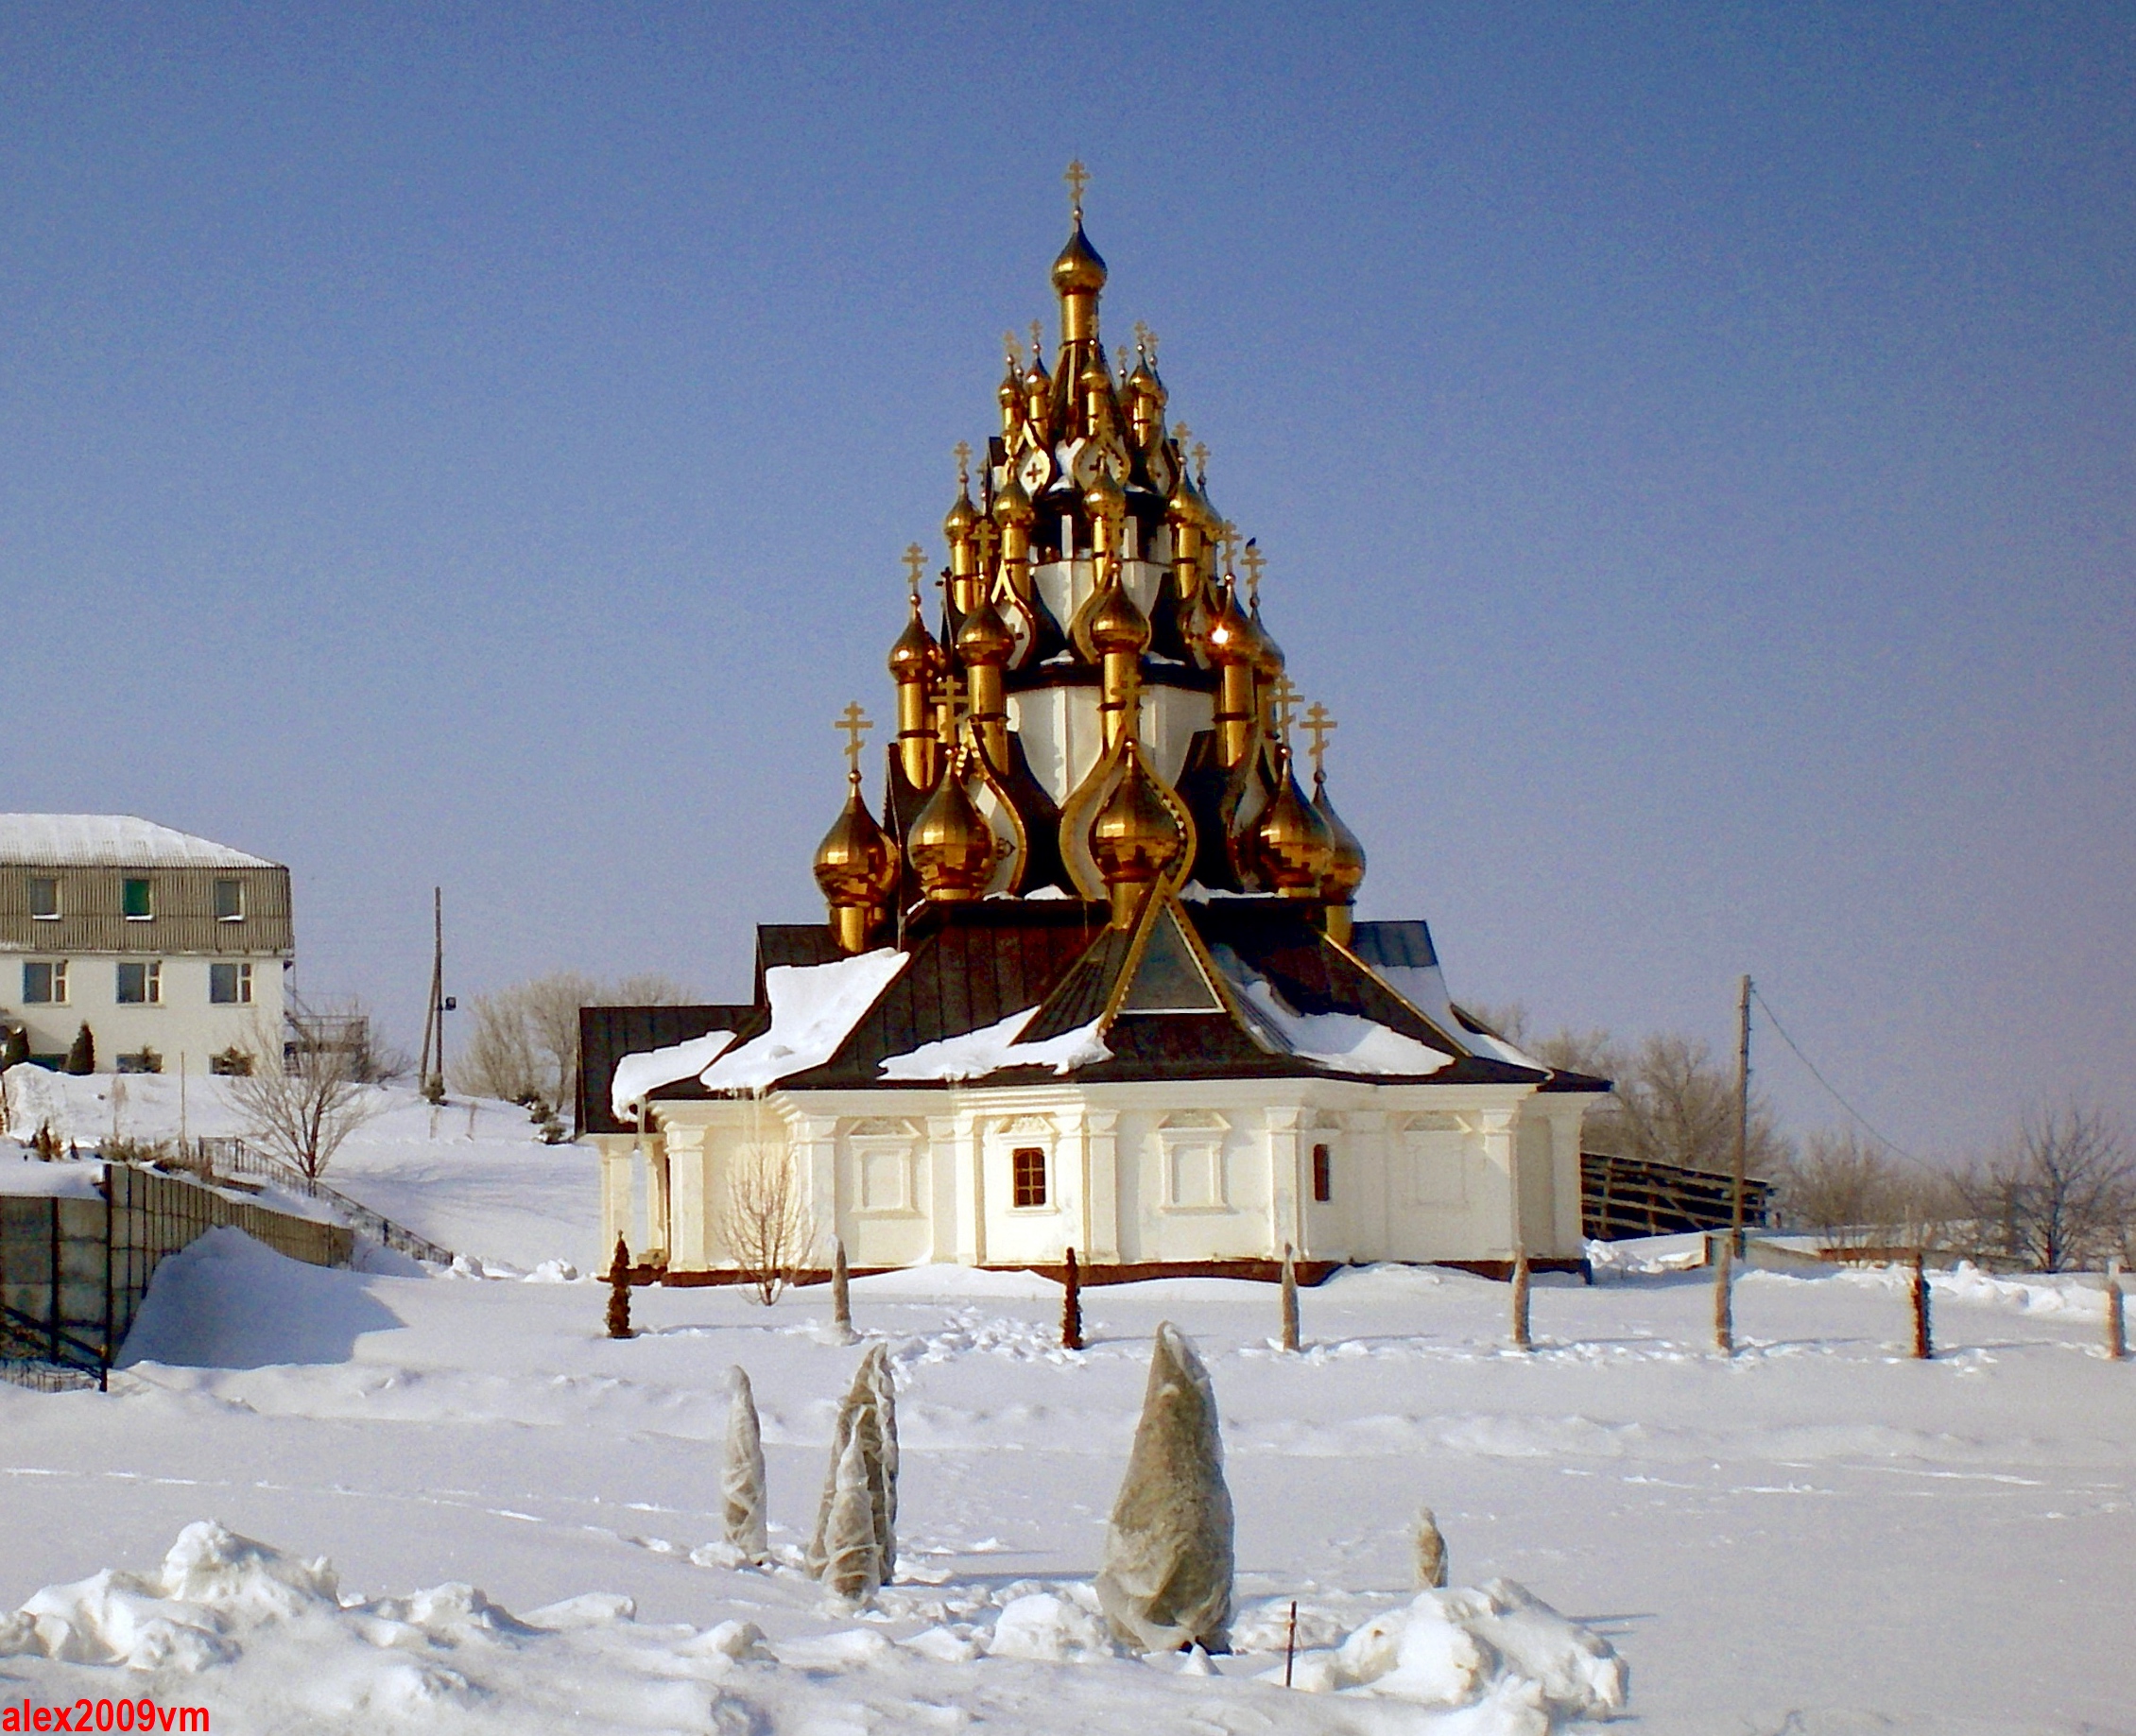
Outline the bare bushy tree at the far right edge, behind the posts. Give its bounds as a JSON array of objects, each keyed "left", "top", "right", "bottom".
[{"left": 1958, "top": 1104, "right": 2136, "bottom": 1273}]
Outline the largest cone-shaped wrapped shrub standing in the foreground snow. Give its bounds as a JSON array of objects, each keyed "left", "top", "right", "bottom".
[{"left": 1098, "top": 1322, "right": 1232, "bottom": 1653}]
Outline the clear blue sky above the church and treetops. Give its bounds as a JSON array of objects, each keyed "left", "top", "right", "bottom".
[{"left": 0, "top": 5, "right": 2136, "bottom": 1151}]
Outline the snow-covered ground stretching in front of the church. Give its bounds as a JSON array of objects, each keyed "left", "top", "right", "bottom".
[{"left": 0, "top": 1080, "right": 2136, "bottom": 1736}]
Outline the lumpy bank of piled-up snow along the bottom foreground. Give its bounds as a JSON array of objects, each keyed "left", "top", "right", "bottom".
[{"left": 0, "top": 1521, "right": 1626, "bottom": 1736}]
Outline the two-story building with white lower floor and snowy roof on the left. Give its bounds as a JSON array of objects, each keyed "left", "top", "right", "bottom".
[{"left": 0, "top": 814, "right": 295, "bottom": 1072}]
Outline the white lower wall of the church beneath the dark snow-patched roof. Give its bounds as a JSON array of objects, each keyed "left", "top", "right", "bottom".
[{"left": 631, "top": 1080, "right": 1592, "bottom": 1270}]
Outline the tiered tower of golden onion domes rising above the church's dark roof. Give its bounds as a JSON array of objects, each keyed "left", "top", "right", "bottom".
[{"left": 818, "top": 164, "right": 1365, "bottom": 950}]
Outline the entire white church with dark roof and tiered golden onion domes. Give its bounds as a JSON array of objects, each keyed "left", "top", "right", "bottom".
[{"left": 578, "top": 166, "right": 1609, "bottom": 1283}]
